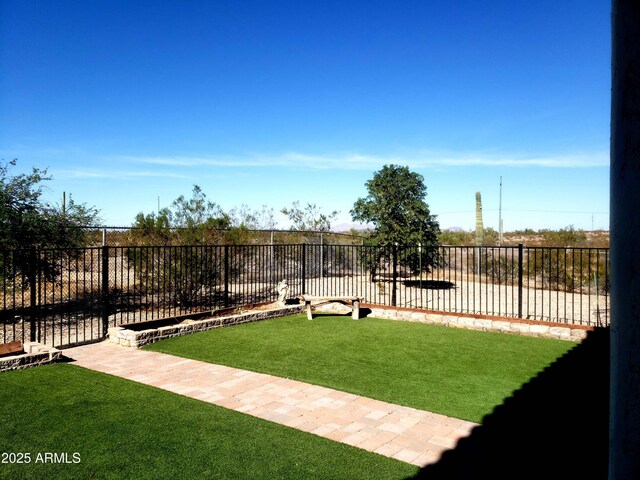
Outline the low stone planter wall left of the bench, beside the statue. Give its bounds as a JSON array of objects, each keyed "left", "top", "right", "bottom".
[{"left": 109, "top": 305, "right": 304, "bottom": 348}]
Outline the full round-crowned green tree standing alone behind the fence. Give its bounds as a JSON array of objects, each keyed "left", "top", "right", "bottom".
[{"left": 351, "top": 165, "right": 441, "bottom": 280}]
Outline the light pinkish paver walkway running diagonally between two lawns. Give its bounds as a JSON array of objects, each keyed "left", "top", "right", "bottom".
[{"left": 64, "top": 342, "right": 477, "bottom": 466}]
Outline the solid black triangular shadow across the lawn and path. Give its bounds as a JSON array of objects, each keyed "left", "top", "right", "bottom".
[{"left": 404, "top": 329, "right": 609, "bottom": 480}]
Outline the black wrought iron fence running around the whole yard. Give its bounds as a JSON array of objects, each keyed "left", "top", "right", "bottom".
[{"left": 0, "top": 244, "right": 609, "bottom": 346}]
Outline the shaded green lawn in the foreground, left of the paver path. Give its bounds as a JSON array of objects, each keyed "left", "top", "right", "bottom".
[{"left": 0, "top": 364, "right": 418, "bottom": 480}]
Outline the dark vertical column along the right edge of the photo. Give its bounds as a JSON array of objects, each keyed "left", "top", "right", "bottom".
[{"left": 609, "top": 0, "right": 640, "bottom": 480}]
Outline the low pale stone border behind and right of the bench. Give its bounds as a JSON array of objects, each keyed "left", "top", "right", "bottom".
[{"left": 316, "top": 304, "right": 595, "bottom": 342}]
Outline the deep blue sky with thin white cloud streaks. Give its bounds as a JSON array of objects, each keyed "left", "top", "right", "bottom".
[{"left": 0, "top": 0, "right": 610, "bottom": 231}]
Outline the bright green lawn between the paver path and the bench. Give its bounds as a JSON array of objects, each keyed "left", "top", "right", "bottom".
[{"left": 145, "top": 315, "right": 575, "bottom": 422}]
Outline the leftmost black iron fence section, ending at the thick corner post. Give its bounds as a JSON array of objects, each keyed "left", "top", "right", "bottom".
[{"left": 0, "top": 248, "right": 104, "bottom": 345}]
